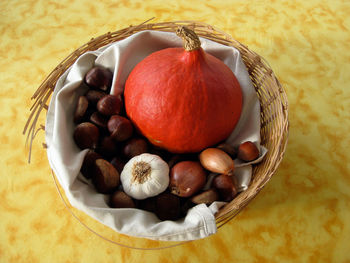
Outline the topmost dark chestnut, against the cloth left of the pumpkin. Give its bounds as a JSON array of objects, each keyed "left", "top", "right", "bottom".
[{"left": 85, "top": 66, "right": 113, "bottom": 91}]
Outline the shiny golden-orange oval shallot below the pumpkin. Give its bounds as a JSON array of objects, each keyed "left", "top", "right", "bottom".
[{"left": 199, "top": 148, "right": 235, "bottom": 175}]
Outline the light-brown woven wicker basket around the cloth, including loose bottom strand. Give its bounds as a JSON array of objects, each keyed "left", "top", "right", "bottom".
[{"left": 23, "top": 21, "right": 289, "bottom": 249}]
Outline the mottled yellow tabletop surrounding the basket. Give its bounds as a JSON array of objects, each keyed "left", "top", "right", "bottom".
[{"left": 0, "top": 0, "right": 350, "bottom": 262}]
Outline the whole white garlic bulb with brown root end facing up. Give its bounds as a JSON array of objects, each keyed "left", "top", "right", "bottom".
[{"left": 120, "top": 153, "right": 169, "bottom": 200}]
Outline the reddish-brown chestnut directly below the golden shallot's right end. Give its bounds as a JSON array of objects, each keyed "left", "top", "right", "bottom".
[{"left": 212, "top": 174, "right": 237, "bottom": 202}]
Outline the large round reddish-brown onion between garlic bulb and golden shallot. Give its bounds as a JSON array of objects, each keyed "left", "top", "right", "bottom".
[{"left": 169, "top": 161, "right": 206, "bottom": 197}]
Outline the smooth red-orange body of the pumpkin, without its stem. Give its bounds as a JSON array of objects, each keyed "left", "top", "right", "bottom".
[{"left": 124, "top": 48, "right": 242, "bottom": 153}]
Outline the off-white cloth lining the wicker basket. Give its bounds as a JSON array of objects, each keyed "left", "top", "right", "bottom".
[{"left": 45, "top": 31, "right": 266, "bottom": 241}]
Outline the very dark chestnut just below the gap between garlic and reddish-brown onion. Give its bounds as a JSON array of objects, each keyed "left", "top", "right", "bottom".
[{"left": 155, "top": 192, "right": 181, "bottom": 220}]
